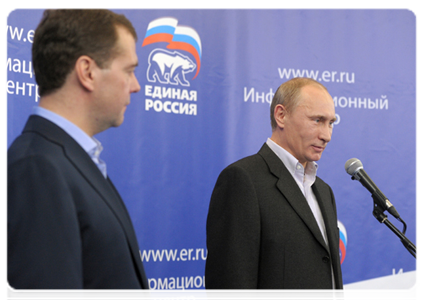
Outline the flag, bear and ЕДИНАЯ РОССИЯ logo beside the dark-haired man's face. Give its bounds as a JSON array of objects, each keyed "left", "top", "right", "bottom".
[{"left": 142, "top": 17, "right": 202, "bottom": 115}]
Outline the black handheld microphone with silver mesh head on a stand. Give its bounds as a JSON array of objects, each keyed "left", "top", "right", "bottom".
[{"left": 345, "top": 158, "right": 400, "bottom": 219}]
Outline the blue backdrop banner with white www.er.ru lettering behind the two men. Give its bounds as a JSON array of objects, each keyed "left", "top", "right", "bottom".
[{"left": 5, "top": 9, "right": 420, "bottom": 300}]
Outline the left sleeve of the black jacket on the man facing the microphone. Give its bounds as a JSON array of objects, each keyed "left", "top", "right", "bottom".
[{"left": 205, "top": 165, "right": 260, "bottom": 300}]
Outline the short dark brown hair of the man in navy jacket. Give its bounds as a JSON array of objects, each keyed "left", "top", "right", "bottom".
[{"left": 32, "top": 8, "right": 137, "bottom": 96}]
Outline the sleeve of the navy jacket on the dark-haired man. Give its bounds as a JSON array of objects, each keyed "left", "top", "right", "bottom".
[{"left": 5, "top": 156, "right": 83, "bottom": 300}]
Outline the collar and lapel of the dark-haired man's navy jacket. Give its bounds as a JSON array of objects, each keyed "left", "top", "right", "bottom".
[{"left": 23, "top": 115, "right": 149, "bottom": 293}]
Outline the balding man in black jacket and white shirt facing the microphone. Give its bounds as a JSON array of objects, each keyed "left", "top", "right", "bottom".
[{"left": 205, "top": 78, "right": 343, "bottom": 300}]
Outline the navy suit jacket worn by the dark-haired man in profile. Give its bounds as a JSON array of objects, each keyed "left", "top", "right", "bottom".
[{"left": 5, "top": 116, "right": 150, "bottom": 300}]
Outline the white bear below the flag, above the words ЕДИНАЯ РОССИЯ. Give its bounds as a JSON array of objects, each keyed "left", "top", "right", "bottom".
[{"left": 147, "top": 49, "right": 197, "bottom": 86}]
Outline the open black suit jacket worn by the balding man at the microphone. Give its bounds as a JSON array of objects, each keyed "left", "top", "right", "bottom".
[{"left": 205, "top": 144, "right": 343, "bottom": 300}]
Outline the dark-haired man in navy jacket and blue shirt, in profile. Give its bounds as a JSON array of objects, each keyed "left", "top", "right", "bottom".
[{"left": 5, "top": 9, "right": 150, "bottom": 300}]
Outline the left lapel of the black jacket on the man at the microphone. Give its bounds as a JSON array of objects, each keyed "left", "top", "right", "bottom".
[{"left": 259, "top": 144, "right": 329, "bottom": 252}]
